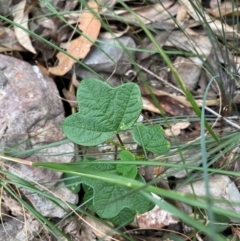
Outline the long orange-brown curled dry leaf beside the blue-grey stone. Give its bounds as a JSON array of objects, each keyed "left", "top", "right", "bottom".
[{"left": 49, "top": 2, "right": 101, "bottom": 75}]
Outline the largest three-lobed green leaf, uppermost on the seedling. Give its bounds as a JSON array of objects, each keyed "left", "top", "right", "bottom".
[{"left": 62, "top": 78, "right": 142, "bottom": 146}]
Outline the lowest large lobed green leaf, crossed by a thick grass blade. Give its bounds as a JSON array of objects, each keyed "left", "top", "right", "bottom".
[{"left": 78, "top": 162, "right": 154, "bottom": 223}]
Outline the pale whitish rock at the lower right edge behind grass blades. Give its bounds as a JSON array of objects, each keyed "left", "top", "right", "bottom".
[{"left": 177, "top": 175, "right": 240, "bottom": 222}]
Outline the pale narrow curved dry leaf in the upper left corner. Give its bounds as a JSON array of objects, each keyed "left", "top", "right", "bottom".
[{"left": 12, "top": 0, "right": 36, "bottom": 54}]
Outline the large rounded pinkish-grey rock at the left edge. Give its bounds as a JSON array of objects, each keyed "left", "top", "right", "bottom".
[{"left": 0, "top": 58, "right": 64, "bottom": 151}]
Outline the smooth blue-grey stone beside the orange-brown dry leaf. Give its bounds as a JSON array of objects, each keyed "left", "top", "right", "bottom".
[{"left": 75, "top": 36, "right": 136, "bottom": 75}]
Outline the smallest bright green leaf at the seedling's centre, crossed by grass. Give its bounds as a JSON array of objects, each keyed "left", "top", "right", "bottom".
[{"left": 116, "top": 150, "right": 138, "bottom": 179}]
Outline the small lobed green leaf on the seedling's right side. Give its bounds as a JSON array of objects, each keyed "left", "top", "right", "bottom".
[{"left": 133, "top": 124, "right": 170, "bottom": 155}]
